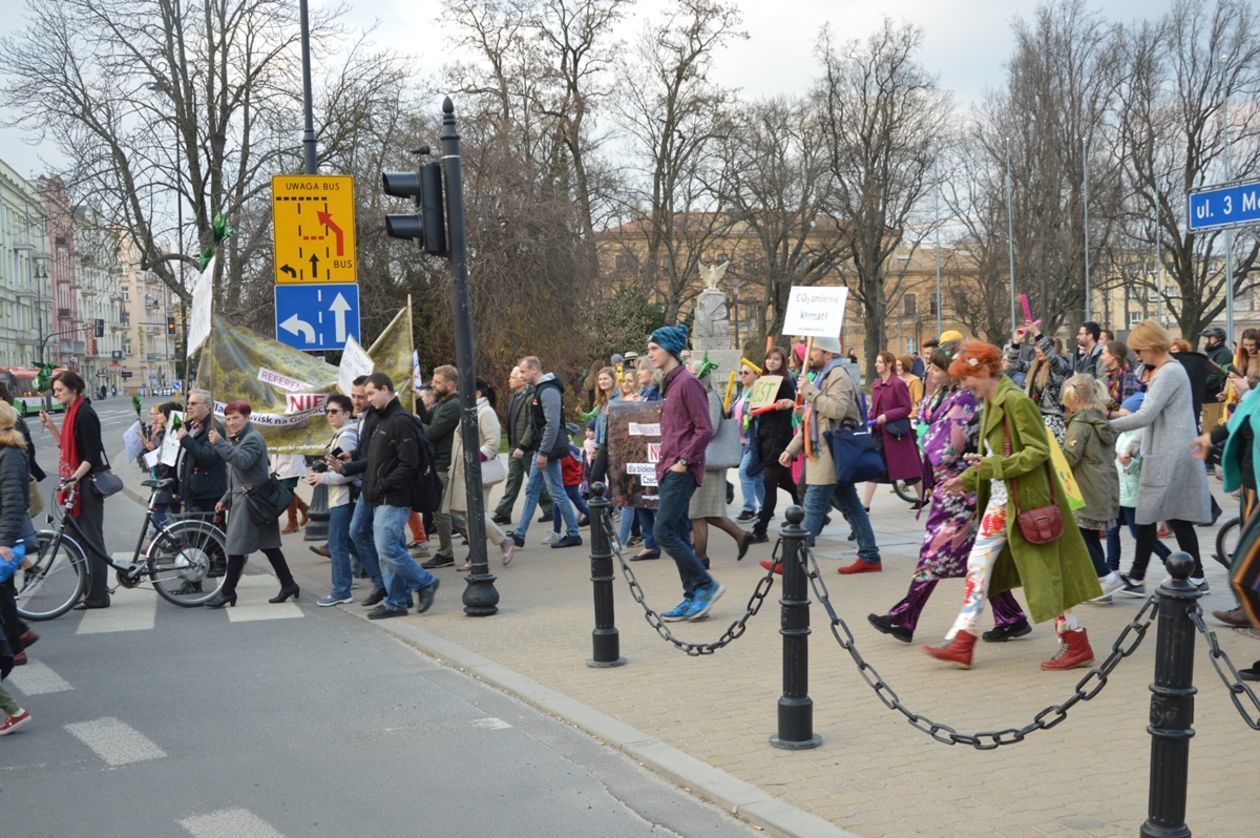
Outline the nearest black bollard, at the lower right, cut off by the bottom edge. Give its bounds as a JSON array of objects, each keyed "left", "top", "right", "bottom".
[{"left": 1140, "top": 553, "right": 1200, "bottom": 838}]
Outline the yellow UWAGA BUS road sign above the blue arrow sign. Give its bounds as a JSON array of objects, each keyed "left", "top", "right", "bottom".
[{"left": 271, "top": 175, "right": 358, "bottom": 285}]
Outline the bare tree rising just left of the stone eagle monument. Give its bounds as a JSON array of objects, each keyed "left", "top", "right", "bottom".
[{"left": 620, "top": 0, "right": 742, "bottom": 321}]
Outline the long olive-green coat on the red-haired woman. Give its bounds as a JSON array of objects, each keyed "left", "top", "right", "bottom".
[{"left": 963, "top": 377, "right": 1103, "bottom": 623}]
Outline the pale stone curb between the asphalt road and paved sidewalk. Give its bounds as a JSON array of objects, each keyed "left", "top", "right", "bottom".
[{"left": 365, "top": 615, "right": 858, "bottom": 838}]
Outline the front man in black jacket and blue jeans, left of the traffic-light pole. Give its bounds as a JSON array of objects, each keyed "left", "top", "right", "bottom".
[{"left": 359, "top": 373, "right": 437, "bottom": 620}]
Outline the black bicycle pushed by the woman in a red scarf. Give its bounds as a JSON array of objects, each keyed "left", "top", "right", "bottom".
[{"left": 16, "top": 479, "right": 227, "bottom": 621}]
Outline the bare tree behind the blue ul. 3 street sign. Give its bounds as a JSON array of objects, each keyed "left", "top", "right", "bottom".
[{"left": 1120, "top": 0, "right": 1260, "bottom": 335}]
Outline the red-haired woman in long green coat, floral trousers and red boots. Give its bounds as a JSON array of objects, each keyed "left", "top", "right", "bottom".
[{"left": 921, "top": 340, "right": 1103, "bottom": 669}]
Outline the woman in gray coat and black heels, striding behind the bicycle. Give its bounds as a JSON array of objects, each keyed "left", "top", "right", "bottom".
[{"left": 207, "top": 401, "right": 299, "bottom": 609}]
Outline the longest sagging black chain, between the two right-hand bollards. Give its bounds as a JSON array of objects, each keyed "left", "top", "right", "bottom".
[{"left": 800, "top": 547, "right": 1159, "bottom": 751}]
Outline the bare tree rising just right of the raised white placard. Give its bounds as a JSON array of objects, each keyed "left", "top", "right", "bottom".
[{"left": 819, "top": 19, "right": 950, "bottom": 376}]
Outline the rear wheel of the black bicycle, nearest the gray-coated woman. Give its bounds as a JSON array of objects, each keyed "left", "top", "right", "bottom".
[{"left": 145, "top": 520, "right": 228, "bottom": 609}]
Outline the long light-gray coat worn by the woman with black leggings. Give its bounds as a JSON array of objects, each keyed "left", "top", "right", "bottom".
[{"left": 1111, "top": 360, "right": 1212, "bottom": 524}]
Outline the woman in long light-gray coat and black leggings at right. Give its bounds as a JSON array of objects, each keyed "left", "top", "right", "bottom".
[{"left": 1111, "top": 320, "right": 1212, "bottom": 596}]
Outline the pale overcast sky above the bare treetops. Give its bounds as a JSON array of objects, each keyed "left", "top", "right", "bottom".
[{"left": 0, "top": 0, "right": 1169, "bottom": 175}]
